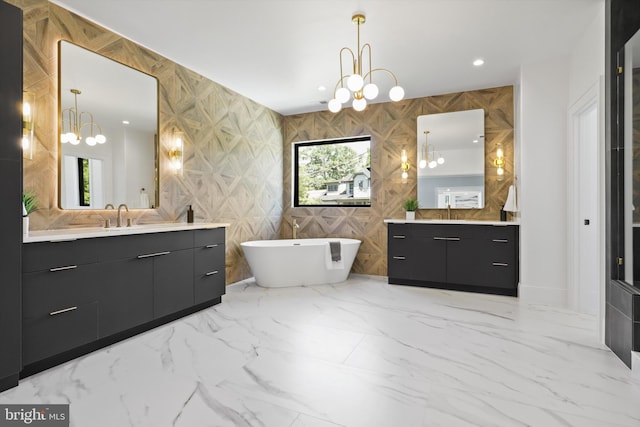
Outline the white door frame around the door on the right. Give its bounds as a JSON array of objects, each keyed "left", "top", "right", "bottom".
[{"left": 567, "top": 76, "right": 606, "bottom": 344}]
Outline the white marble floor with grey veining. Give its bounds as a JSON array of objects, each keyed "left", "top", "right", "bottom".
[{"left": 0, "top": 276, "right": 640, "bottom": 427}]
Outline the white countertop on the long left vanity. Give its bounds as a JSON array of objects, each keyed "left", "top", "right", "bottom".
[{"left": 22, "top": 222, "right": 230, "bottom": 243}]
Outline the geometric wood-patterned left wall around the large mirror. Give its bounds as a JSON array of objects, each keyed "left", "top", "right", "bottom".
[{"left": 6, "top": 0, "right": 283, "bottom": 283}]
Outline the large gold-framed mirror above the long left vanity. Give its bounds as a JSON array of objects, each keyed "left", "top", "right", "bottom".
[{"left": 58, "top": 40, "right": 159, "bottom": 209}]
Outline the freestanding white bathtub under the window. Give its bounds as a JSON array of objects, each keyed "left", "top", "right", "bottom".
[{"left": 240, "top": 238, "right": 360, "bottom": 288}]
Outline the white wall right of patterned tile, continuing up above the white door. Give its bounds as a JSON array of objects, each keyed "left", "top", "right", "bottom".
[{"left": 515, "top": 2, "right": 605, "bottom": 306}]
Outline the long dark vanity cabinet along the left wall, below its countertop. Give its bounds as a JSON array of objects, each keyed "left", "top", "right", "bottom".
[{"left": 22, "top": 227, "right": 225, "bottom": 376}]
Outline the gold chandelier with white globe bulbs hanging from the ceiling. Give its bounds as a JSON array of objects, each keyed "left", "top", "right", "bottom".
[{"left": 328, "top": 14, "right": 404, "bottom": 113}]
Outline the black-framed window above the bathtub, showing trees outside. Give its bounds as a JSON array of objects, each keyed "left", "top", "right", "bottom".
[{"left": 293, "top": 136, "right": 371, "bottom": 206}]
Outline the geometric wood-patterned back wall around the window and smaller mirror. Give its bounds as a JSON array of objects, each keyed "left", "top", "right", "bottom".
[{"left": 281, "top": 86, "right": 514, "bottom": 276}]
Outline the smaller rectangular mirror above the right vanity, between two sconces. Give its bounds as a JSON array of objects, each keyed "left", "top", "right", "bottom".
[{"left": 416, "top": 109, "right": 485, "bottom": 209}]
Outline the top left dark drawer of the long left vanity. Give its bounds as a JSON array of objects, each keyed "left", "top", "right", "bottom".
[{"left": 22, "top": 239, "right": 98, "bottom": 272}]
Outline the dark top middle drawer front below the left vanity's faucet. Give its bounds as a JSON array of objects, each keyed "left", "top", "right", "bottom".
[{"left": 100, "top": 230, "right": 193, "bottom": 261}]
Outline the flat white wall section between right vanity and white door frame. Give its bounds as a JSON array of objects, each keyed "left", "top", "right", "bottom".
[{"left": 518, "top": 58, "right": 569, "bottom": 306}]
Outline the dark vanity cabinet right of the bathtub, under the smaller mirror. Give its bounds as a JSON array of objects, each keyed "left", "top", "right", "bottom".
[{"left": 387, "top": 222, "right": 519, "bottom": 296}]
